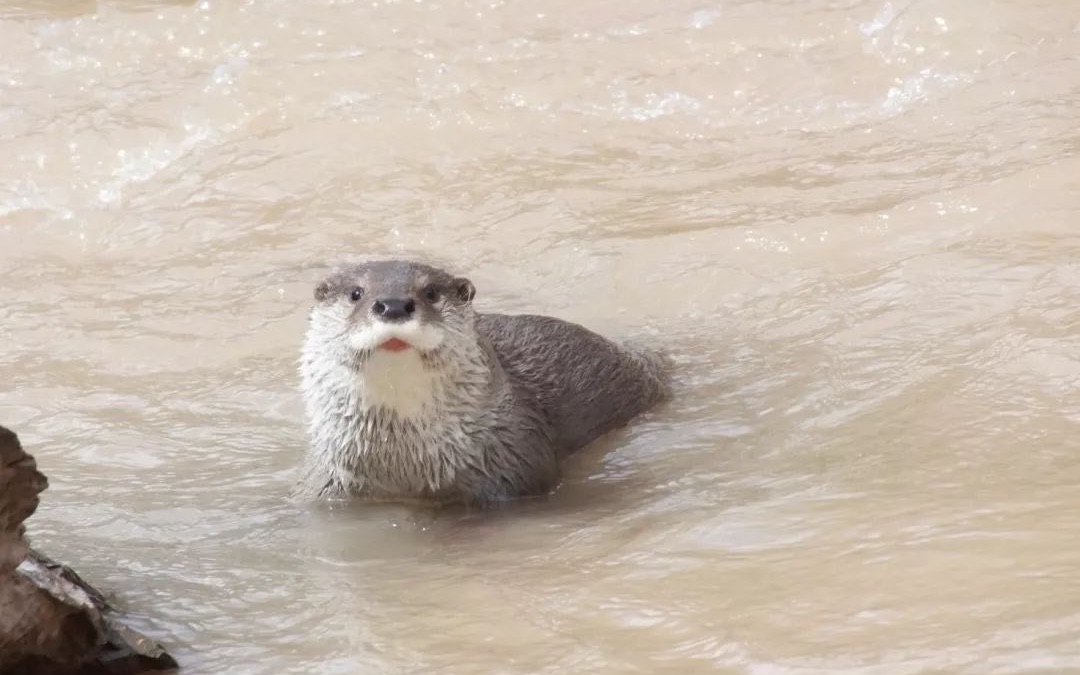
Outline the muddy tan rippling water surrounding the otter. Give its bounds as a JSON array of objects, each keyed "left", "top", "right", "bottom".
[{"left": 0, "top": 0, "right": 1080, "bottom": 675}]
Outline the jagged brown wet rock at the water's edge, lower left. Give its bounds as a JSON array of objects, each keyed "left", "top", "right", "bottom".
[{"left": 0, "top": 427, "right": 177, "bottom": 675}]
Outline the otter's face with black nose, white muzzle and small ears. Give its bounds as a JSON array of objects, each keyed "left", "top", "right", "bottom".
[{"left": 314, "top": 260, "right": 476, "bottom": 355}]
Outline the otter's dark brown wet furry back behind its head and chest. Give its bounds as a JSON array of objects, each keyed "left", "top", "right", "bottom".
[{"left": 476, "top": 314, "right": 667, "bottom": 451}]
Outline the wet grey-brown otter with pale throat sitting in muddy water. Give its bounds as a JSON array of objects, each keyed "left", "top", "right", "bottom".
[{"left": 295, "top": 259, "right": 671, "bottom": 508}]
